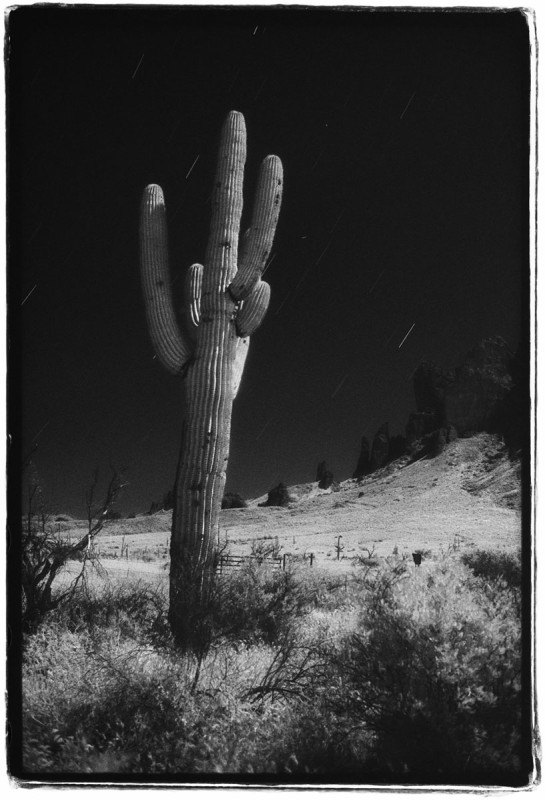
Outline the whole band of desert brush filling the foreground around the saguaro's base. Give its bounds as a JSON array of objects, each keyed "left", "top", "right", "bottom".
[{"left": 22, "top": 549, "right": 527, "bottom": 785}]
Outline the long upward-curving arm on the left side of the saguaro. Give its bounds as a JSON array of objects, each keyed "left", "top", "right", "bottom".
[{"left": 140, "top": 184, "right": 192, "bottom": 375}]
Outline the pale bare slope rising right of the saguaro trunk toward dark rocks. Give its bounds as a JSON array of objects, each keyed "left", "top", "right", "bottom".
[{"left": 221, "top": 434, "right": 521, "bottom": 564}]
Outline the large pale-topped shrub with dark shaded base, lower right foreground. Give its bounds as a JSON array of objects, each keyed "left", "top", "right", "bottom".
[{"left": 334, "top": 559, "right": 521, "bottom": 783}]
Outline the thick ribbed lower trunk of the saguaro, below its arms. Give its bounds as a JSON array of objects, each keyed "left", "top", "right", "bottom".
[{"left": 169, "top": 308, "right": 236, "bottom": 648}]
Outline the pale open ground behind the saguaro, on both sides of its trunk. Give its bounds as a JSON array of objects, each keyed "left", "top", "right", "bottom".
[{"left": 56, "top": 434, "right": 521, "bottom": 580}]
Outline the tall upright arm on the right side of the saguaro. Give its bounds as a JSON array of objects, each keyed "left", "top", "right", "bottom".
[{"left": 229, "top": 156, "right": 284, "bottom": 300}]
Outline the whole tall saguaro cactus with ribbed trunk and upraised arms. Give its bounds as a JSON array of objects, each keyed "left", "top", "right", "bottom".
[{"left": 140, "top": 111, "right": 283, "bottom": 646}]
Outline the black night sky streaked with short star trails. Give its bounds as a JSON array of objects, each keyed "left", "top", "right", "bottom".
[{"left": 7, "top": 6, "right": 529, "bottom": 515}]
